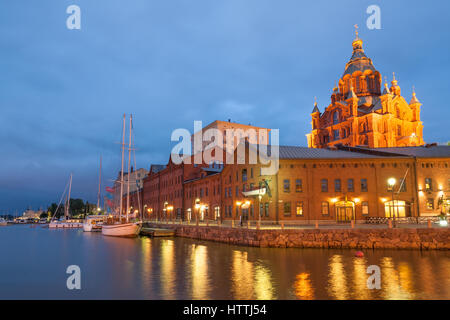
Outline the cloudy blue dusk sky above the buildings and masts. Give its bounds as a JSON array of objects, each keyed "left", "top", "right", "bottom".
[{"left": 0, "top": 0, "right": 450, "bottom": 214}]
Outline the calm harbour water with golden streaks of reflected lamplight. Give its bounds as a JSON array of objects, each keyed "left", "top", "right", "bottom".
[{"left": 0, "top": 226, "right": 450, "bottom": 300}]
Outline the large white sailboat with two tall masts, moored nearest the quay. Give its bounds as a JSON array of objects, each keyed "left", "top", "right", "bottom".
[{"left": 102, "top": 115, "right": 141, "bottom": 237}]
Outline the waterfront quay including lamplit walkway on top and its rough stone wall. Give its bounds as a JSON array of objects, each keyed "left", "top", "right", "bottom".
[{"left": 146, "top": 221, "right": 450, "bottom": 250}]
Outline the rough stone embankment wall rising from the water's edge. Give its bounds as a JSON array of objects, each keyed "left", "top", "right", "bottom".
[{"left": 149, "top": 224, "right": 450, "bottom": 250}]
